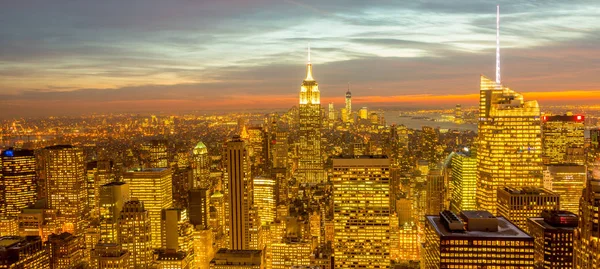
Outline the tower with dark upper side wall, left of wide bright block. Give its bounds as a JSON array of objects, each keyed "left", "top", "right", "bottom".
[{"left": 99, "top": 182, "right": 129, "bottom": 243}]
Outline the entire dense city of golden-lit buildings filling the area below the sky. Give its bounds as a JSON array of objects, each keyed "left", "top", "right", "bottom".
[{"left": 0, "top": 6, "right": 600, "bottom": 269}]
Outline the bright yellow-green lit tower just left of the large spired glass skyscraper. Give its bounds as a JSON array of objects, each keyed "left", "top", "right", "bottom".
[{"left": 450, "top": 153, "right": 477, "bottom": 213}]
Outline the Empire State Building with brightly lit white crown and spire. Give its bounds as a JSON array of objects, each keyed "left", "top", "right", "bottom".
[{"left": 298, "top": 47, "right": 325, "bottom": 183}]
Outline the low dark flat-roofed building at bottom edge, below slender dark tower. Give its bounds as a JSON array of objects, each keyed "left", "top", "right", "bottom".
[{"left": 210, "top": 248, "right": 264, "bottom": 269}]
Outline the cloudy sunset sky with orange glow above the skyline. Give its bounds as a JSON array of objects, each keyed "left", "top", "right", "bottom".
[{"left": 0, "top": 0, "right": 600, "bottom": 116}]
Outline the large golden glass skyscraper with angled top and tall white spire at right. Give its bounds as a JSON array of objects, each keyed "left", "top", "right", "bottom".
[{"left": 477, "top": 5, "right": 542, "bottom": 214}]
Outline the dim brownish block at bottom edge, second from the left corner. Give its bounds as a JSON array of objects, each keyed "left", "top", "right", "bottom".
[{"left": 48, "top": 233, "right": 83, "bottom": 269}]
